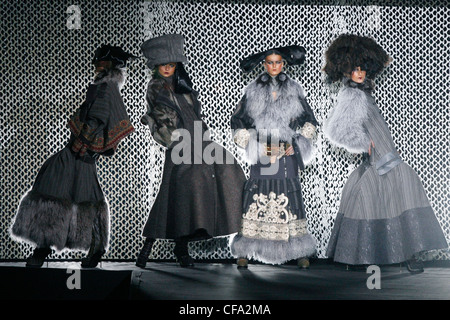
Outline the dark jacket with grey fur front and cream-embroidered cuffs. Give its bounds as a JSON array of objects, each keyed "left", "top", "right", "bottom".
[{"left": 231, "top": 72, "right": 318, "bottom": 169}]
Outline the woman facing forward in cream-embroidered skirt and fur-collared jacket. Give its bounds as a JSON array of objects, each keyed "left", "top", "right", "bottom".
[{"left": 230, "top": 46, "right": 318, "bottom": 268}]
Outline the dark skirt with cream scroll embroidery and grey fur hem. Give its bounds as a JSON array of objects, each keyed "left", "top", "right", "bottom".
[{"left": 230, "top": 156, "right": 316, "bottom": 264}]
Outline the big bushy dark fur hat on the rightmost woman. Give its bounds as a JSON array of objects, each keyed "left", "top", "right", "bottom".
[{"left": 322, "top": 34, "right": 392, "bottom": 82}]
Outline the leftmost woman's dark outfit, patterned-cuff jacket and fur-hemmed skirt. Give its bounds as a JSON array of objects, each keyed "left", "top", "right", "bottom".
[{"left": 10, "top": 69, "right": 134, "bottom": 251}]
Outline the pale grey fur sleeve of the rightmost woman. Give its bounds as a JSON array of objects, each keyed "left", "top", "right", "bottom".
[{"left": 323, "top": 83, "right": 370, "bottom": 153}]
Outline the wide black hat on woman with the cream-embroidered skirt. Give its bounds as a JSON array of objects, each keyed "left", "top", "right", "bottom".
[{"left": 240, "top": 45, "right": 306, "bottom": 73}]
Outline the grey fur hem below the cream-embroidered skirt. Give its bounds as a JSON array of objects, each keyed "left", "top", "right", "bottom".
[{"left": 230, "top": 234, "right": 316, "bottom": 264}]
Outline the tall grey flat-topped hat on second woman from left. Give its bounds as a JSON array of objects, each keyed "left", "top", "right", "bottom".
[{"left": 141, "top": 34, "right": 187, "bottom": 69}]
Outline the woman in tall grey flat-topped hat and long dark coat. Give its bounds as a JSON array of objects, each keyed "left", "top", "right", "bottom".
[{"left": 136, "top": 34, "right": 245, "bottom": 268}]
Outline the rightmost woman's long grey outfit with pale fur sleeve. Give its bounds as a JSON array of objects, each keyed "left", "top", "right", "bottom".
[{"left": 324, "top": 80, "right": 447, "bottom": 264}]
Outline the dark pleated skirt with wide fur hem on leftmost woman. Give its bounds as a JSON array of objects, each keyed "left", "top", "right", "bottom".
[{"left": 10, "top": 146, "right": 109, "bottom": 251}]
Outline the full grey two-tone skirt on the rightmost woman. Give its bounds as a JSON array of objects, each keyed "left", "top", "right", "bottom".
[{"left": 327, "top": 156, "right": 448, "bottom": 265}]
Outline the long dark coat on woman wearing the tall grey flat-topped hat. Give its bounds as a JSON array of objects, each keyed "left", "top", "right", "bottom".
[{"left": 141, "top": 77, "right": 246, "bottom": 239}]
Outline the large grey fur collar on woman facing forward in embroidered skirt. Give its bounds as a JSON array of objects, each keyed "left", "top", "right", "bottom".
[{"left": 245, "top": 72, "right": 304, "bottom": 142}]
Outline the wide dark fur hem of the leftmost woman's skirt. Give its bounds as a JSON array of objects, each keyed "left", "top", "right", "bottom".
[{"left": 9, "top": 190, "right": 109, "bottom": 252}]
